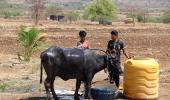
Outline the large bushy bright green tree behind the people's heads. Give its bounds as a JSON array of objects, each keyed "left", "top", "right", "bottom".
[{"left": 84, "top": 0, "right": 116, "bottom": 22}]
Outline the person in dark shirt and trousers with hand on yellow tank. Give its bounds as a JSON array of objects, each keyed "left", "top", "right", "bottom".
[{"left": 107, "top": 30, "right": 131, "bottom": 87}]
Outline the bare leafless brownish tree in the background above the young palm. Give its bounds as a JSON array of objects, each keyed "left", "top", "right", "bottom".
[{"left": 26, "top": 0, "right": 45, "bottom": 25}]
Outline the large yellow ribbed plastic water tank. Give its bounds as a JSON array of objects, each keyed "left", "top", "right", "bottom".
[{"left": 123, "top": 58, "right": 159, "bottom": 99}]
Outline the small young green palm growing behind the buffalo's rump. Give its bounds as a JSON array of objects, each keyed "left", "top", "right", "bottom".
[{"left": 18, "top": 26, "right": 45, "bottom": 61}]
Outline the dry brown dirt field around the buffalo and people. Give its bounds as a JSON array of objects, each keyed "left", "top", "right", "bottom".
[{"left": 0, "top": 19, "right": 170, "bottom": 100}]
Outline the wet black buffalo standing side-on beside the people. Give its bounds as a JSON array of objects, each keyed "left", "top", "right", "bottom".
[{"left": 40, "top": 46, "right": 119, "bottom": 100}]
